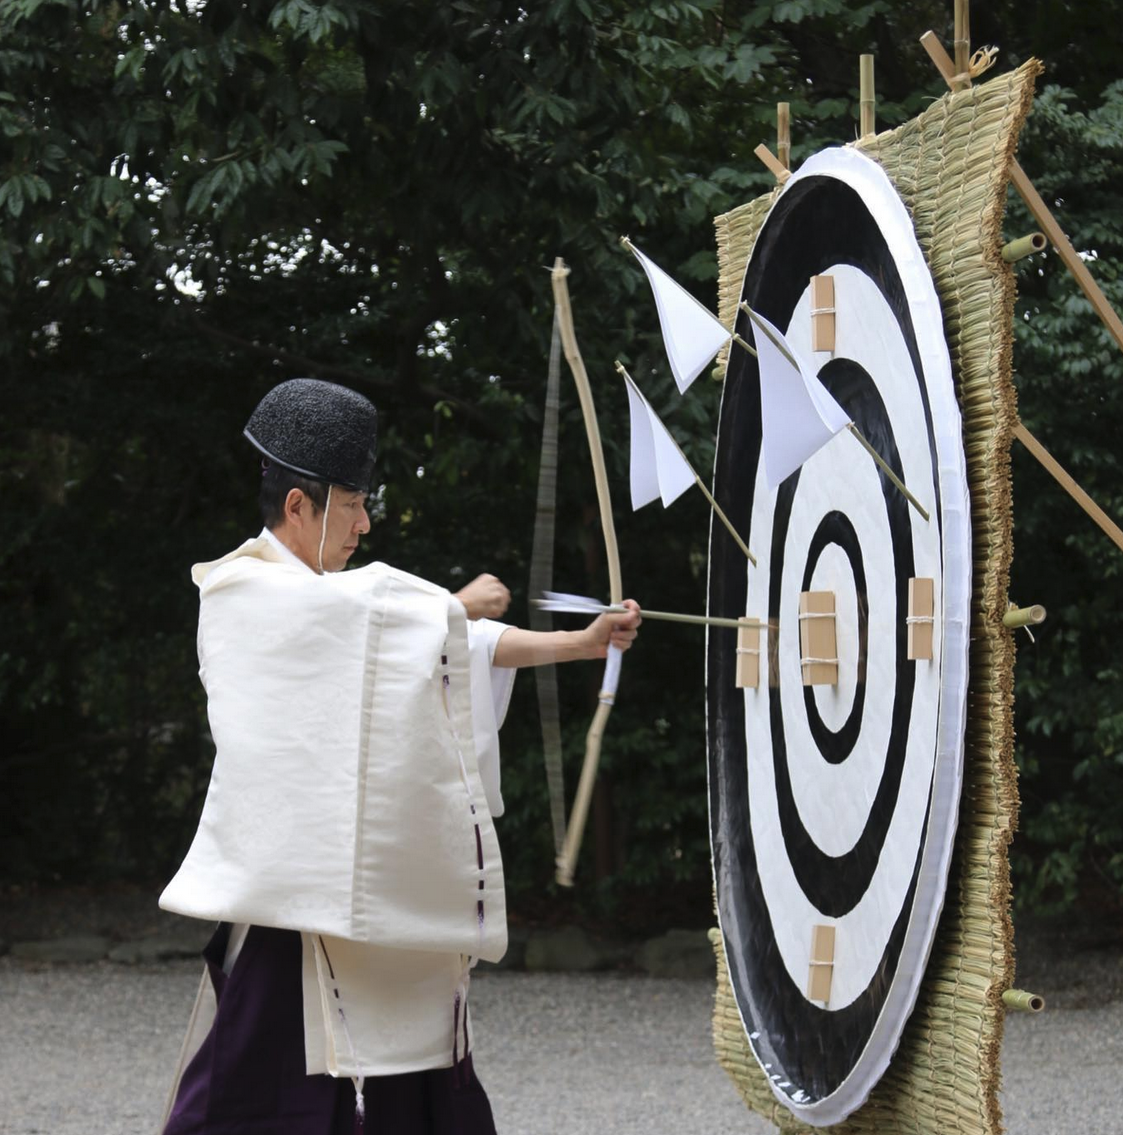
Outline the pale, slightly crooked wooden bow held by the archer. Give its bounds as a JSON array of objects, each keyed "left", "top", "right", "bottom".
[{"left": 551, "top": 257, "right": 623, "bottom": 886}]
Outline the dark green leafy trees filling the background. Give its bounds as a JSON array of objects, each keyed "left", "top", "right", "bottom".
[{"left": 0, "top": 0, "right": 1123, "bottom": 922}]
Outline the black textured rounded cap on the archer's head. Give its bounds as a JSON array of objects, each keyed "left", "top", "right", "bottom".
[{"left": 243, "top": 378, "right": 378, "bottom": 493}]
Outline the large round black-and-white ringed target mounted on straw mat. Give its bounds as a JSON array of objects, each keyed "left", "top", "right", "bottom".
[{"left": 706, "top": 149, "right": 971, "bottom": 1126}]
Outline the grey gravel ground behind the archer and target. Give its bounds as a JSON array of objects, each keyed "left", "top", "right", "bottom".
[{"left": 0, "top": 949, "right": 1123, "bottom": 1135}]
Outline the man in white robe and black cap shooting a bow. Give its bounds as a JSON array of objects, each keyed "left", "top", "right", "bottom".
[{"left": 160, "top": 379, "right": 639, "bottom": 1135}]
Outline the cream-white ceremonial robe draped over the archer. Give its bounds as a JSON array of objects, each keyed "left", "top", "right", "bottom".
[{"left": 160, "top": 533, "right": 513, "bottom": 1103}]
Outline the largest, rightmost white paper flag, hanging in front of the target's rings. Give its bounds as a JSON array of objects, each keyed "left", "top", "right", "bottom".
[{"left": 751, "top": 311, "right": 850, "bottom": 488}]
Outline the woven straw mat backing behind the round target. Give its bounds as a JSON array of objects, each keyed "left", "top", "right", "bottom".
[{"left": 711, "top": 60, "right": 1041, "bottom": 1135}]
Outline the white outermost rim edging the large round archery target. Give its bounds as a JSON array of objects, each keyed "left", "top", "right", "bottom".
[{"left": 706, "top": 146, "right": 972, "bottom": 1127}]
